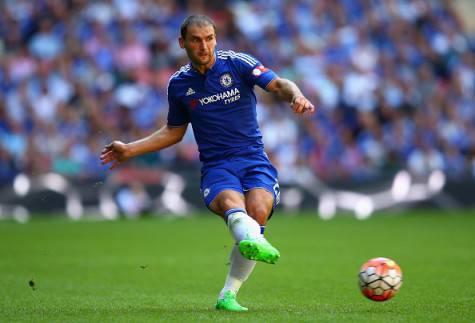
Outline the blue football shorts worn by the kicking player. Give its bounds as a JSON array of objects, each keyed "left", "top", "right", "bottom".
[{"left": 201, "top": 154, "right": 280, "bottom": 208}]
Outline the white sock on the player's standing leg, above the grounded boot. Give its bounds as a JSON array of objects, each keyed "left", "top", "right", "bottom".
[{"left": 219, "top": 245, "right": 256, "bottom": 299}]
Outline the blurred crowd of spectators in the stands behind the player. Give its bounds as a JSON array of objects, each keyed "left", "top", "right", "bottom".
[{"left": 0, "top": 0, "right": 475, "bottom": 183}]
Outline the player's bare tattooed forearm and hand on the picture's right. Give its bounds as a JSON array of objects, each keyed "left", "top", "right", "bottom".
[{"left": 266, "top": 77, "right": 315, "bottom": 114}]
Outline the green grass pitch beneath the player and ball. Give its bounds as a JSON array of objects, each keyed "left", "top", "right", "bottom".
[{"left": 0, "top": 211, "right": 475, "bottom": 322}]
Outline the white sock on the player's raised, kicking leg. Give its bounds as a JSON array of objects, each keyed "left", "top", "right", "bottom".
[{"left": 226, "top": 209, "right": 262, "bottom": 242}]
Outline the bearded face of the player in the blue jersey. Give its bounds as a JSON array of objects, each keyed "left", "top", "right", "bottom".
[{"left": 179, "top": 25, "right": 216, "bottom": 67}]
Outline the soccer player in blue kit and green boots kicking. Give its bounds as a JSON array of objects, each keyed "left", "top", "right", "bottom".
[{"left": 100, "top": 15, "right": 315, "bottom": 311}]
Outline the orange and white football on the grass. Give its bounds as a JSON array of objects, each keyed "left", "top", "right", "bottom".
[{"left": 359, "top": 258, "right": 402, "bottom": 302}]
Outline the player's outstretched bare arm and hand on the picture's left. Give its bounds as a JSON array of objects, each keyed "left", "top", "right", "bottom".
[{"left": 100, "top": 124, "right": 188, "bottom": 169}]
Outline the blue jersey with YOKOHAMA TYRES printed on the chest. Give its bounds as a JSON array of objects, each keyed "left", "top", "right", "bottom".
[{"left": 168, "top": 50, "right": 277, "bottom": 162}]
